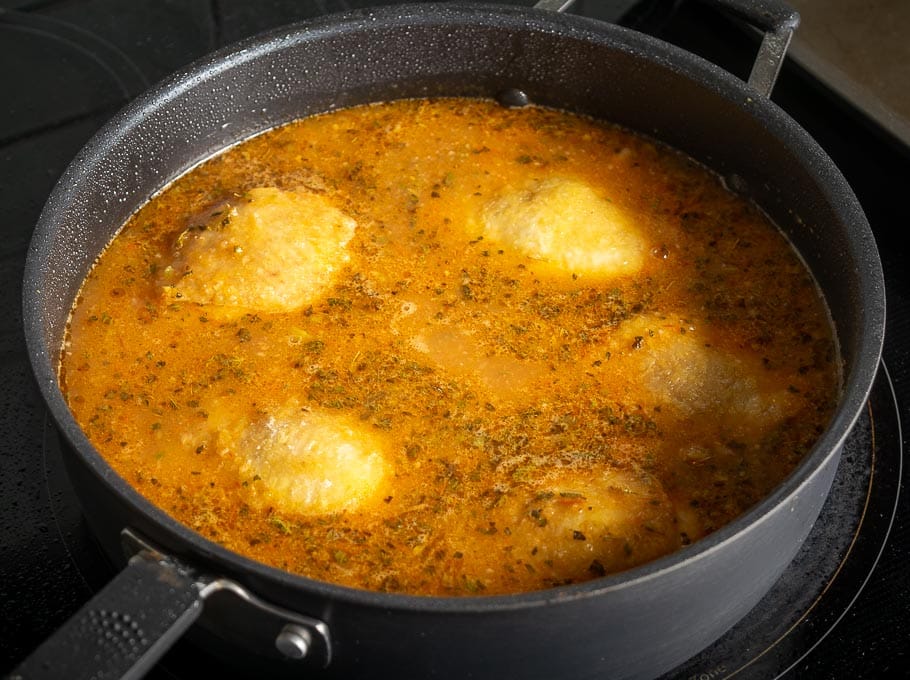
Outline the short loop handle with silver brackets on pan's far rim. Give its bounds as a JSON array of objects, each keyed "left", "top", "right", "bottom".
[{"left": 534, "top": 0, "right": 799, "bottom": 98}]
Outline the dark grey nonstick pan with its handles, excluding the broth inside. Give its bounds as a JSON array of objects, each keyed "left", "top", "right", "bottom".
[{"left": 14, "top": 0, "right": 885, "bottom": 678}]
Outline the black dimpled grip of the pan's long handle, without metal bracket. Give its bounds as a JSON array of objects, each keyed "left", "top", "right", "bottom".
[{"left": 10, "top": 553, "right": 202, "bottom": 680}]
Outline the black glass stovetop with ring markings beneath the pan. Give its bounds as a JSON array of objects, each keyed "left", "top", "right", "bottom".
[{"left": 0, "top": 0, "right": 910, "bottom": 680}]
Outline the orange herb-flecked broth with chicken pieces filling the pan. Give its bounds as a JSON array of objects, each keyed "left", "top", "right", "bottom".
[{"left": 61, "top": 99, "right": 840, "bottom": 595}]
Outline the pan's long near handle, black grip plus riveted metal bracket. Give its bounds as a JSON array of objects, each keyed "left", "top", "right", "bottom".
[{"left": 6, "top": 529, "right": 333, "bottom": 680}]
